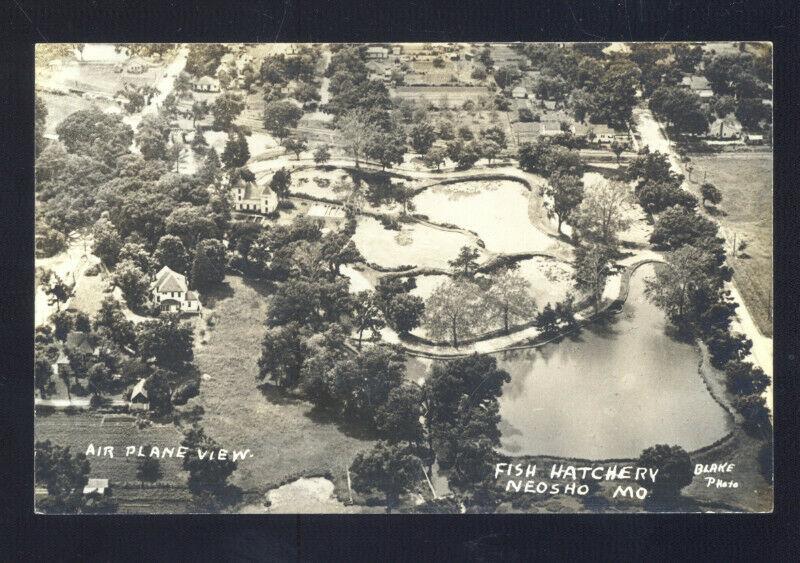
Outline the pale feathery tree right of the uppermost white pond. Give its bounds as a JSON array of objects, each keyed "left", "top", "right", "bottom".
[{"left": 575, "top": 179, "right": 631, "bottom": 246}]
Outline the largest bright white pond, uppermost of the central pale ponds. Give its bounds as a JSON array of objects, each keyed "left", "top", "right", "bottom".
[{"left": 414, "top": 180, "right": 553, "bottom": 252}]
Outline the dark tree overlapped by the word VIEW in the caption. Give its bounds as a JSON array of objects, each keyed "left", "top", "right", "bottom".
[{"left": 181, "top": 425, "right": 236, "bottom": 501}]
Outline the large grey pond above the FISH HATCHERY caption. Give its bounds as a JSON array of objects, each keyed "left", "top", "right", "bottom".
[{"left": 498, "top": 265, "right": 730, "bottom": 459}]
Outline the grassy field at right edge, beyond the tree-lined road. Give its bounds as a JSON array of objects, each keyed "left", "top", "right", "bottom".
[{"left": 691, "top": 152, "right": 773, "bottom": 336}]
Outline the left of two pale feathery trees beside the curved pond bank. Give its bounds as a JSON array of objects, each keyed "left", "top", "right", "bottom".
[{"left": 424, "top": 279, "right": 484, "bottom": 347}]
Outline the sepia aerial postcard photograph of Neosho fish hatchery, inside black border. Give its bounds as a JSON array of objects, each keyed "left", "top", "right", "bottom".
[{"left": 32, "top": 41, "right": 776, "bottom": 515}]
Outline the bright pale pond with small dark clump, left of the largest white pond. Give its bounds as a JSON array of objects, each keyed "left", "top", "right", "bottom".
[{"left": 353, "top": 217, "right": 474, "bottom": 268}]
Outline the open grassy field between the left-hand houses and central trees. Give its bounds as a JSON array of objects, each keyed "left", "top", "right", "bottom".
[{"left": 187, "top": 276, "right": 372, "bottom": 491}]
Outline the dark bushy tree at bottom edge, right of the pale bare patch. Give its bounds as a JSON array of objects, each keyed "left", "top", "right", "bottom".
[{"left": 350, "top": 441, "right": 422, "bottom": 514}]
